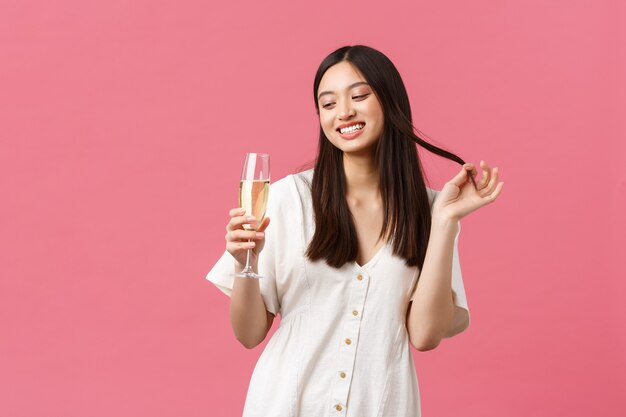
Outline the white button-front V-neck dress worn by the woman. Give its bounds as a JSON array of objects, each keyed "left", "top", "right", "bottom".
[{"left": 207, "top": 169, "right": 469, "bottom": 417}]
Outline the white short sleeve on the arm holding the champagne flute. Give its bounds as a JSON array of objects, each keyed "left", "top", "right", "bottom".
[{"left": 206, "top": 182, "right": 285, "bottom": 315}]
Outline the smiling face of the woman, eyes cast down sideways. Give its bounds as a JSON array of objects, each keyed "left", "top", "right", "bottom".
[{"left": 317, "top": 61, "right": 383, "bottom": 153}]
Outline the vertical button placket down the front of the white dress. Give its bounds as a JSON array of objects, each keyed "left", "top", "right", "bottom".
[{"left": 332, "top": 272, "right": 369, "bottom": 413}]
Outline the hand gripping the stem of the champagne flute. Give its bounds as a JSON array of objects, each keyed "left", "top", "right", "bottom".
[{"left": 226, "top": 207, "right": 270, "bottom": 265}]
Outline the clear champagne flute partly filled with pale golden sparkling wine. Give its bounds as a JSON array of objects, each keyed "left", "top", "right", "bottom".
[{"left": 233, "top": 153, "right": 270, "bottom": 278}]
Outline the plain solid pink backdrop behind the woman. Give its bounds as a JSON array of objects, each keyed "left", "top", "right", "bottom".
[{"left": 0, "top": 0, "right": 626, "bottom": 417}]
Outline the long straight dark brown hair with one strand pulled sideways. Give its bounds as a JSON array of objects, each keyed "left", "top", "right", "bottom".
[{"left": 306, "top": 45, "right": 465, "bottom": 269}]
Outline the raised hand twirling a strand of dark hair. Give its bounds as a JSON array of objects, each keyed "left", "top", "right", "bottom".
[{"left": 433, "top": 161, "right": 504, "bottom": 221}]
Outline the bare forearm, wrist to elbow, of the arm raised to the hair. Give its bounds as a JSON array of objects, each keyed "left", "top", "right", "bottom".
[{"left": 407, "top": 217, "right": 459, "bottom": 351}]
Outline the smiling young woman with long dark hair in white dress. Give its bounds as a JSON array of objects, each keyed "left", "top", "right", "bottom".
[{"left": 207, "top": 45, "right": 504, "bottom": 417}]
